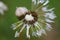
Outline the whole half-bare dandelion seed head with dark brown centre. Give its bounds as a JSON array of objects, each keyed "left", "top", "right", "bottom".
[{"left": 13, "top": 0, "right": 56, "bottom": 39}]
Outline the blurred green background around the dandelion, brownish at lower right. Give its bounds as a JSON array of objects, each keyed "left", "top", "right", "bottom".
[{"left": 0, "top": 0, "right": 60, "bottom": 40}]
